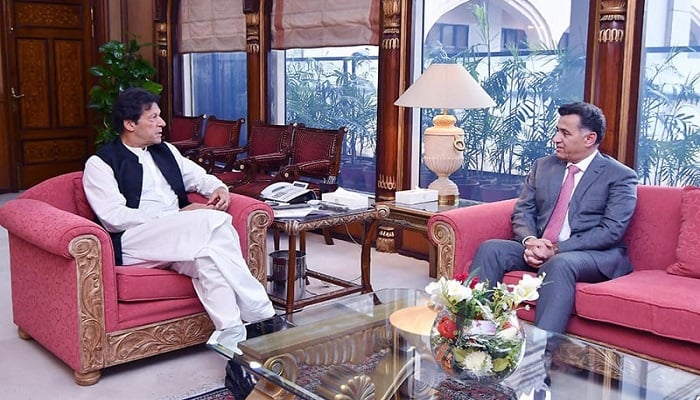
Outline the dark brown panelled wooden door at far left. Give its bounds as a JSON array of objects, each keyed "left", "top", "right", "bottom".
[{"left": 4, "top": 0, "right": 94, "bottom": 189}]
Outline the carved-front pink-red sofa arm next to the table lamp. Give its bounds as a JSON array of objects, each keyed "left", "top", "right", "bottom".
[{"left": 427, "top": 199, "right": 515, "bottom": 279}]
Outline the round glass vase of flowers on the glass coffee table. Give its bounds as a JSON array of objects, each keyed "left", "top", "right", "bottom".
[{"left": 430, "top": 309, "right": 525, "bottom": 382}]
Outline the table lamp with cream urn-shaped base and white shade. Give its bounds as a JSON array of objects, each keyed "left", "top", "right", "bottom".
[{"left": 394, "top": 64, "right": 496, "bottom": 205}]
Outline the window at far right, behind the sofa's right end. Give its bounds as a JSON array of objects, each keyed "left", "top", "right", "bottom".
[{"left": 636, "top": 1, "right": 700, "bottom": 186}]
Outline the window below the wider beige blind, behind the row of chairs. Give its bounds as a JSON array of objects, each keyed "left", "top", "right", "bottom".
[{"left": 270, "top": 46, "right": 379, "bottom": 192}]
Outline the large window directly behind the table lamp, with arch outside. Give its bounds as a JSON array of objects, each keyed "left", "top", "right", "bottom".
[{"left": 413, "top": 0, "right": 588, "bottom": 201}]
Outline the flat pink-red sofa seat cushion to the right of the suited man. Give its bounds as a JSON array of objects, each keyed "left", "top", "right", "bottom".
[{"left": 576, "top": 270, "right": 700, "bottom": 343}]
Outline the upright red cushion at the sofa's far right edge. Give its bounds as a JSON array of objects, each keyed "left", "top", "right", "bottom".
[{"left": 667, "top": 186, "right": 700, "bottom": 278}]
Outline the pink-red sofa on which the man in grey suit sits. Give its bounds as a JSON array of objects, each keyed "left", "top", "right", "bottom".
[{"left": 428, "top": 186, "right": 700, "bottom": 372}]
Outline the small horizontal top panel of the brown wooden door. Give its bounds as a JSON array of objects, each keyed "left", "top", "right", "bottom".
[{"left": 15, "top": 2, "right": 82, "bottom": 28}]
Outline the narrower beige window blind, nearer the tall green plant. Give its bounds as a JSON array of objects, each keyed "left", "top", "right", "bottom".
[{"left": 179, "top": 0, "right": 246, "bottom": 53}]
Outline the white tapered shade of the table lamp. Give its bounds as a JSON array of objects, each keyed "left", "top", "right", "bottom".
[{"left": 394, "top": 64, "right": 496, "bottom": 109}]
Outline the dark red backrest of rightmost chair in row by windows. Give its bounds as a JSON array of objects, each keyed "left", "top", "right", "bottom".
[{"left": 290, "top": 125, "right": 347, "bottom": 180}]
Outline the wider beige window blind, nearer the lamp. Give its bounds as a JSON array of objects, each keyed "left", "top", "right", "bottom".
[{"left": 272, "top": 0, "right": 381, "bottom": 49}]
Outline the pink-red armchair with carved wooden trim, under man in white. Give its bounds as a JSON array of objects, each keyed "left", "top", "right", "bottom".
[{"left": 0, "top": 172, "right": 273, "bottom": 385}]
